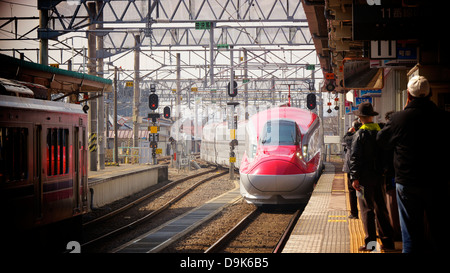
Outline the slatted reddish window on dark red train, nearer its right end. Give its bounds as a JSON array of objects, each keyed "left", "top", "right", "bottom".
[{"left": 47, "top": 128, "right": 69, "bottom": 176}]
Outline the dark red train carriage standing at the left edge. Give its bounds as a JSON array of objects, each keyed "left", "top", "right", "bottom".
[{"left": 0, "top": 88, "right": 88, "bottom": 248}]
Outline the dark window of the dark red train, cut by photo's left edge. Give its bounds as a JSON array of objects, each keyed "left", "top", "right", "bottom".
[{"left": 0, "top": 127, "right": 28, "bottom": 183}]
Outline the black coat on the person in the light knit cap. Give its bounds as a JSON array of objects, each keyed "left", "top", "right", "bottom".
[{"left": 377, "top": 96, "right": 449, "bottom": 186}]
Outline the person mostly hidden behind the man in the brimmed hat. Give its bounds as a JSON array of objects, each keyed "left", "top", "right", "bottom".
[{"left": 342, "top": 118, "right": 361, "bottom": 219}]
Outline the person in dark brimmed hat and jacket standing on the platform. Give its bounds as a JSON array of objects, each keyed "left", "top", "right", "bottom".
[{"left": 349, "top": 102, "right": 395, "bottom": 251}]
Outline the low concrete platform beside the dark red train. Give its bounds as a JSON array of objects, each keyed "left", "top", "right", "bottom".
[{"left": 88, "top": 164, "right": 168, "bottom": 207}]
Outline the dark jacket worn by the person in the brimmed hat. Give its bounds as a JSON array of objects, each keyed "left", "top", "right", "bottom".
[{"left": 349, "top": 123, "right": 383, "bottom": 186}]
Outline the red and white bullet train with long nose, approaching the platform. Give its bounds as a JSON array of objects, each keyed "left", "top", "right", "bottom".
[{"left": 201, "top": 107, "right": 323, "bottom": 205}]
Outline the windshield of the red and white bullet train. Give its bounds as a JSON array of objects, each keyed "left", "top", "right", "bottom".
[{"left": 261, "top": 119, "right": 300, "bottom": 145}]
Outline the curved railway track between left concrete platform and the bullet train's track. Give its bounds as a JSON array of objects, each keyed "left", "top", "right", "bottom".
[{"left": 81, "top": 167, "right": 227, "bottom": 252}]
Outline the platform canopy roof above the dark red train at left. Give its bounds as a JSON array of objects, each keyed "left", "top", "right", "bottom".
[{"left": 0, "top": 54, "right": 112, "bottom": 97}]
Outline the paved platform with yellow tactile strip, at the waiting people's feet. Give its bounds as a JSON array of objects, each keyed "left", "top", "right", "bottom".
[{"left": 283, "top": 161, "right": 402, "bottom": 253}]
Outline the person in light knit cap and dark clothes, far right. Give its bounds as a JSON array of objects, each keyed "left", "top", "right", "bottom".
[{"left": 377, "top": 76, "right": 450, "bottom": 253}]
